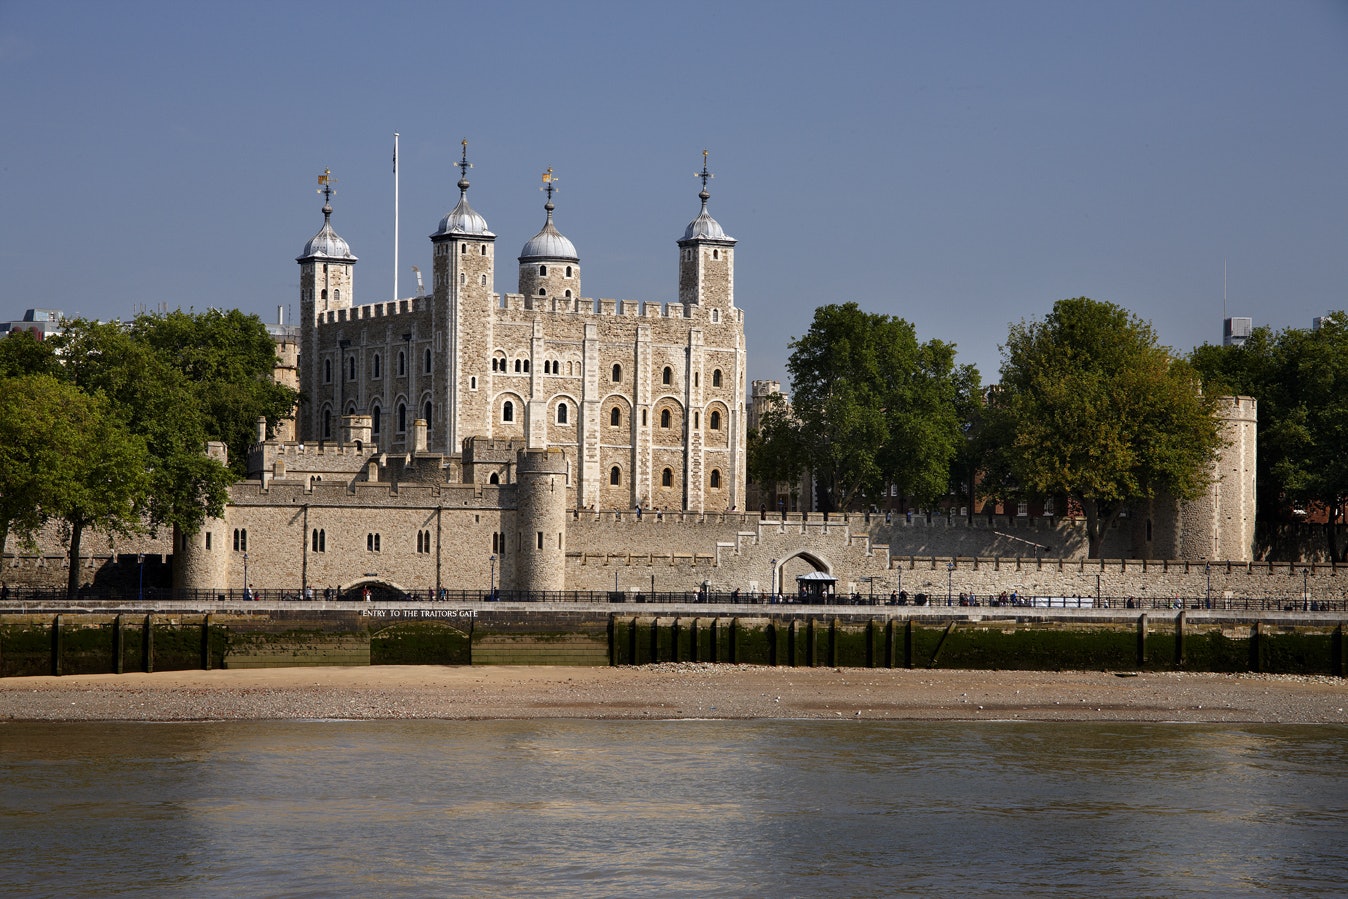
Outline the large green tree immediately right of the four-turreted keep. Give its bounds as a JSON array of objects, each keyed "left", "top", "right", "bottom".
[{"left": 758, "top": 303, "right": 977, "bottom": 511}]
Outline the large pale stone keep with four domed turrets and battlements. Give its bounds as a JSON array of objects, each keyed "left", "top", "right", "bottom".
[{"left": 297, "top": 142, "right": 745, "bottom": 511}]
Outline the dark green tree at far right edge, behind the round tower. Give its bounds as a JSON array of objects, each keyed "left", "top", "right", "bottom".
[{"left": 1192, "top": 311, "right": 1348, "bottom": 561}]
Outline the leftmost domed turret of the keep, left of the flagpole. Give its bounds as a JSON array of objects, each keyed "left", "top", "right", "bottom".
[{"left": 295, "top": 168, "right": 356, "bottom": 439}]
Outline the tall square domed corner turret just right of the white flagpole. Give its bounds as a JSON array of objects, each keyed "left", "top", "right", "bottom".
[{"left": 430, "top": 140, "right": 496, "bottom": 453}]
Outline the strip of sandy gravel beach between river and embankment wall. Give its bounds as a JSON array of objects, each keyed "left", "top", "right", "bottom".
[{"left": 0, "top": 663, "right": 1348, "bottom": 724}]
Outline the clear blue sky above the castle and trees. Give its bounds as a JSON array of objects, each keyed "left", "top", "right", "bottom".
[{"left": 0, "top": 0, "right": 1348, "bottom": 381}]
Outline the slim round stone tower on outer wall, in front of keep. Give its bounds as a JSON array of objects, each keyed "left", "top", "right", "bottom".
[{"left": 515, "top": 447, "right": 566, "bottom": 593}]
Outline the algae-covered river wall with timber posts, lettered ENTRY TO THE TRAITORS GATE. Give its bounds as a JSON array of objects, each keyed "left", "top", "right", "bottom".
[{"left": 0, "top": 604, "right": 1348, "bottom": 677}]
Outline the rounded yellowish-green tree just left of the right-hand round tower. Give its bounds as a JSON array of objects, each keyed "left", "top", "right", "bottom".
[{"left": 988, "top": 297, "right": 1220, "bottom": 558}]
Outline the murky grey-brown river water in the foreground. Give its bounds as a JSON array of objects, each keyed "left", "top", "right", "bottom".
[{"left": 0, "top": 720, "right": 1348, "bottom": 898}]
